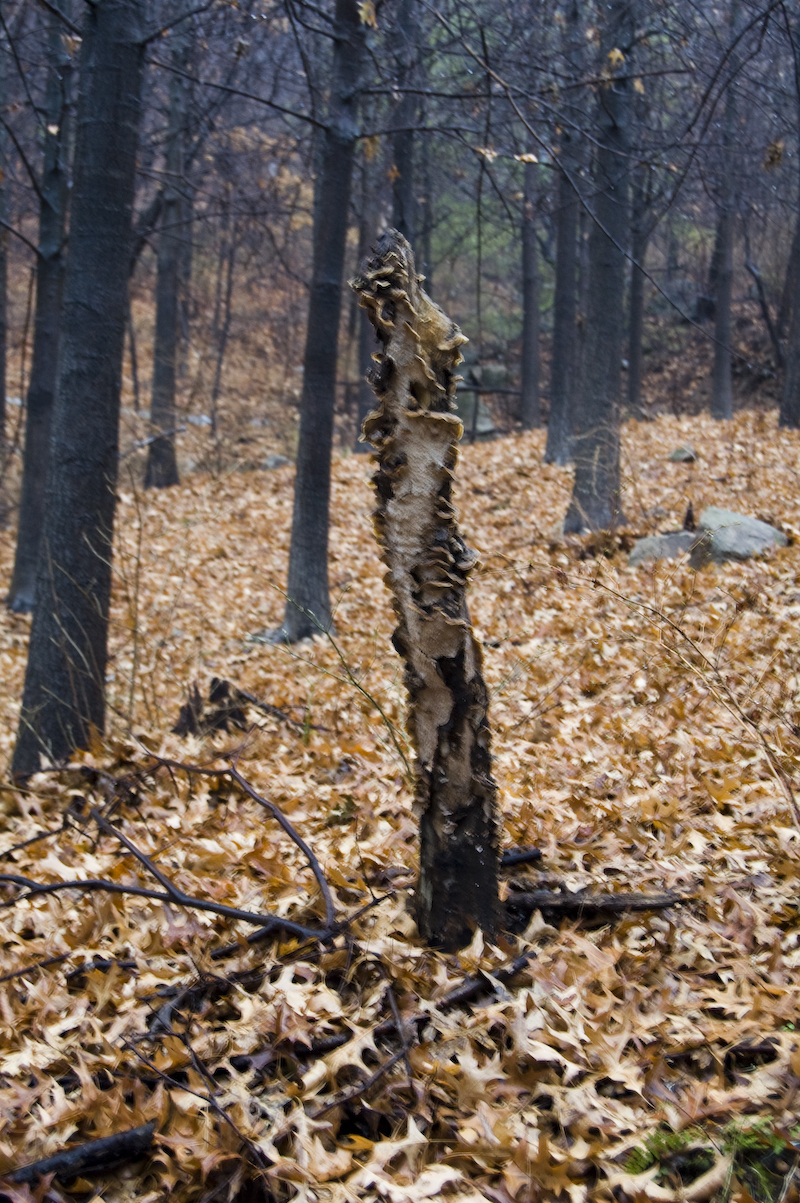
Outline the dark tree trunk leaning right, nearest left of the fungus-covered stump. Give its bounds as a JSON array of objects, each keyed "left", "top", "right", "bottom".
[{"left": 275, "top": 0, "right": 365, "bottom": 642}]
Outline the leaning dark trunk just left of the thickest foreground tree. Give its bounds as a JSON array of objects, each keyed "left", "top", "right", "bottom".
[{"left": 7, "top": 6, "right": 72, "bottom": 614}]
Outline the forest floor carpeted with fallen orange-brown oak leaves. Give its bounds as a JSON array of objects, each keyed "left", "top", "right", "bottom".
[{"left": 0, "top": 411, "right": 800, "bottom": 1203}]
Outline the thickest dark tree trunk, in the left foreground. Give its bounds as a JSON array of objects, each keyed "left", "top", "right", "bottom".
[{"left": 12, "top": 0, "right": 144, "bottom": 777}]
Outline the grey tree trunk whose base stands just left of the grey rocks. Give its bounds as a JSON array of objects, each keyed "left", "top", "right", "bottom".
[{"left": 564, "top": 0, "right": 633, "bottom": 533}]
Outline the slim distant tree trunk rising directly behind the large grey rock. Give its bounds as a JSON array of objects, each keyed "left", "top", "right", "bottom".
[{"left": 711, "top": 0, "right": 739, "bottom": 421}]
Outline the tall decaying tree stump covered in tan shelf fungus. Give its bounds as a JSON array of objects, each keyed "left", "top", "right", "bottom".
[{"left": 352, "top": 230, "right": 498, "bottom": 949}]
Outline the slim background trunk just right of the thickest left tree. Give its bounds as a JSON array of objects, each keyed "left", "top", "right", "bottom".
[{"left": 144, "top": 32, "right": 189, "bottom": 488}]
